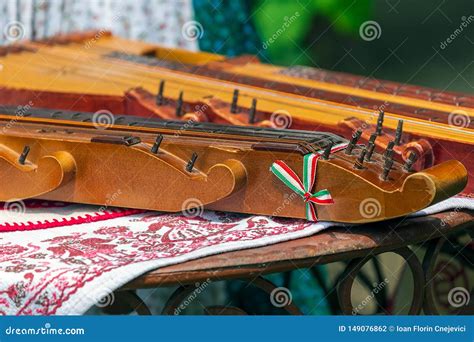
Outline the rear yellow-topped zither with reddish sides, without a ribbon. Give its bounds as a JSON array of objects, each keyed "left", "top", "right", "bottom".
[{"left": 0, "top": 31, "right": 474, "bottom": 195}]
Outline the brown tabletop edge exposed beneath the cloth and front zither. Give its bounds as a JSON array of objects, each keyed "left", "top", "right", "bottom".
[{"left": 123, "top": 210, "right": 474, "bottom": 289}]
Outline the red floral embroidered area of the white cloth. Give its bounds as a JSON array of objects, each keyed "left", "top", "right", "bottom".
[{"left": 0, "top": 212, "right": 312, "bottom": 315}]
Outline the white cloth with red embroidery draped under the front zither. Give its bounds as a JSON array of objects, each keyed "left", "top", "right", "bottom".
[{"left": 0, "top": 198, "right": 474, "bottom": 315}]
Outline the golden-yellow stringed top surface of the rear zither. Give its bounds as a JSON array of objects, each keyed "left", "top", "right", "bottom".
[{"left": 0, "top": 35, "right": 474, "bottom": 145}]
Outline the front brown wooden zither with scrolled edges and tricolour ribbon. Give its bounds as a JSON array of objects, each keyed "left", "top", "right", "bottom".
[{"left": 0, "top": 108, "right": 467, "bottom": 223}]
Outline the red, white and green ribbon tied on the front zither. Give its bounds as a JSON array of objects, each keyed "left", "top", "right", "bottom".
[{"left": 270, "top": 143, "right": 347, "bottom": 221}]
